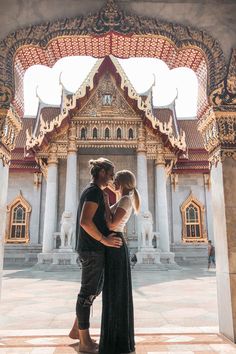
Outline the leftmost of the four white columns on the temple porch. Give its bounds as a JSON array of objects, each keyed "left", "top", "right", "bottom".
[{"left": 42, "top": 155, "right": 58, "bottom": 253}]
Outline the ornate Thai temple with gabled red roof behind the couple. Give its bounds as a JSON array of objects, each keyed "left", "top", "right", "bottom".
[{"left": 5, "top": 55, "right": 214, "bottom": 265}]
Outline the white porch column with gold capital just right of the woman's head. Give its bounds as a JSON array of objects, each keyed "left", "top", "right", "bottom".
[{"left": 137, "top": 127, "right": 149, "bottom": 212}]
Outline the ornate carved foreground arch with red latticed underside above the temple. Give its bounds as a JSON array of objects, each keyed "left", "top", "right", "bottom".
[{"left": 0, "top": 0, "right": 226, "bottom": 119}]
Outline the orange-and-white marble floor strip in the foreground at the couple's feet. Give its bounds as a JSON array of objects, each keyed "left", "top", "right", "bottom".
[{"left": 0, "top": 333, "right": 236, "bottom": 354}]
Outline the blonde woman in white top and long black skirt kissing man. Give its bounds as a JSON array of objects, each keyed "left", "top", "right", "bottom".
[{"left": 99, "top": 170, "right": 140, "bottom": 354}]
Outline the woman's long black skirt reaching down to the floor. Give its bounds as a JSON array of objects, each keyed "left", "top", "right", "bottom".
[{"left": 99, "top": 232, "right": 135, "bottom": 354}]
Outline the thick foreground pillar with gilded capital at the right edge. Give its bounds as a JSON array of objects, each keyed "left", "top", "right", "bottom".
[{"left": 199, "top": 102, "right": 236, "bottom": 342}]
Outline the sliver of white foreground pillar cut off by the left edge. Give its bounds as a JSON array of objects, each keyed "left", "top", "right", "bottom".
[{"left": 0, "top": 158, "right": 9, "bottom": 298}]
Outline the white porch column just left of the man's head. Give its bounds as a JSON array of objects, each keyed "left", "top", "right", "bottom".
[{"left": 65, "top": 151, "right": 77, "bottom": 219}]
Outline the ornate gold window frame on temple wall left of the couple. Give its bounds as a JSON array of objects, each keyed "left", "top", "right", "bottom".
[{"left": 5, "top": 191, "right": 32, "bottom": 243}]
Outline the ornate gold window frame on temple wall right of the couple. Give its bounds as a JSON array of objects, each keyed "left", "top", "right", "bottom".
[{"left": 180, "top": 193, "right": 207, "bottom": 243}]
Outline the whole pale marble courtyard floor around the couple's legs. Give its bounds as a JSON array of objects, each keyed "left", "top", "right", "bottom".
[{"left": 0, "top": 266, "right": 236, "bottom": 354}]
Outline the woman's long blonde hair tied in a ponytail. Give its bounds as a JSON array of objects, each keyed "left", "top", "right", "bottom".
[{"left": 115, "top": 170, "right": 141, "bottom": 214}]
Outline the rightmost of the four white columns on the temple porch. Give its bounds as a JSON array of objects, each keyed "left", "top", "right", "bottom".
[{"left": 155, "top": 159, "right": 170, "bottom": 252}]
